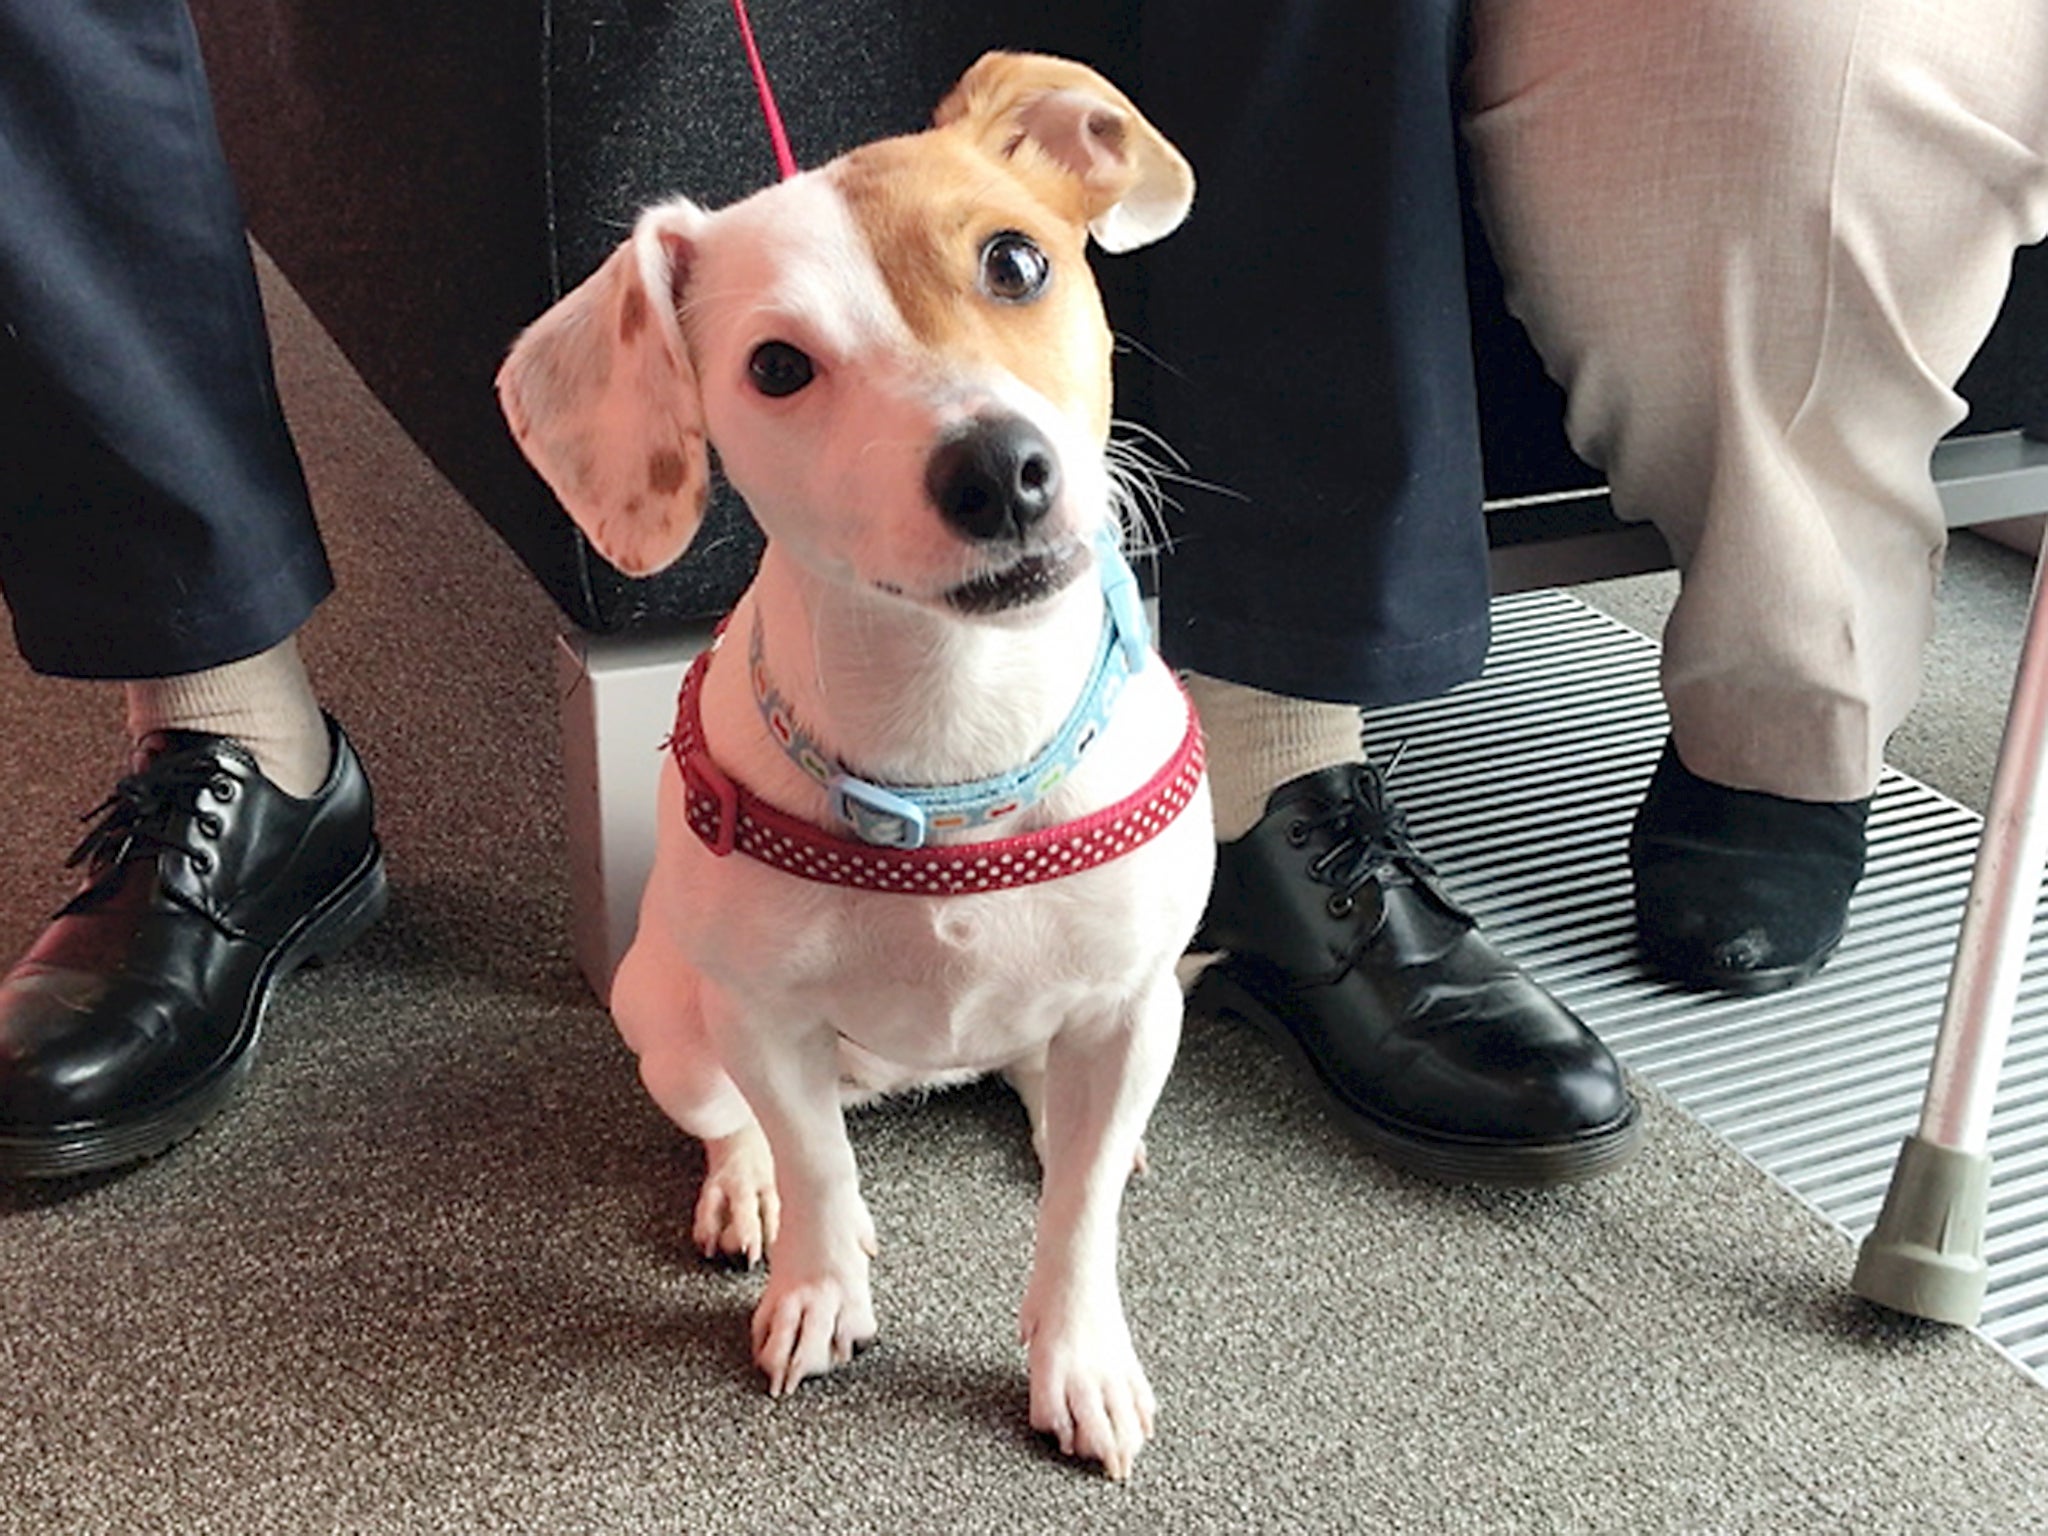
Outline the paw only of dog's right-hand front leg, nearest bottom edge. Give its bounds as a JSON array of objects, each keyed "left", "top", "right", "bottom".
[{"left": 1022, "top": 1307, "right": 1157, "bottom": 1479}]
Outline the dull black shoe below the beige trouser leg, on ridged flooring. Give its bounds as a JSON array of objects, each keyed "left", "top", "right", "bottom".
[{"left": 1628, "top": 741, "right": 1870, "bottom": 995}]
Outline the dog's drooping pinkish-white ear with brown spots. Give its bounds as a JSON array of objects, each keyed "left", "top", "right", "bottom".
[{"left": 498, "top": 201, "right": 709, "bottom": 575}]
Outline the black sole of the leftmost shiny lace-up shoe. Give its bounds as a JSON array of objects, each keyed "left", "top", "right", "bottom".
[{"left": 0, "top": 838, "right": 389, "bottom": 1180}]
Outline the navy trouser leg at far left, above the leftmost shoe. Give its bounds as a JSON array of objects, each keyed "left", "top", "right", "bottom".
[{"left": 0, "top": 0, "right": 332, "bottom": 678}]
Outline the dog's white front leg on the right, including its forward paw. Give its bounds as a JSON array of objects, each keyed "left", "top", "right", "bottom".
[{"left": 1020, "top": 975, "right": 1182, "bottom": 1477}]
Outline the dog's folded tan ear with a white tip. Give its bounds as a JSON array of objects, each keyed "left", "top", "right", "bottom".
[{"left": 932, "top": 53, "right": 1194, "bottom": 252}]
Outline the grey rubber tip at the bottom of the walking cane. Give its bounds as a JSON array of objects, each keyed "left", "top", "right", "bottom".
[{"left": 1849, "top": 1137, "right": 1991, "bottom": 1327}]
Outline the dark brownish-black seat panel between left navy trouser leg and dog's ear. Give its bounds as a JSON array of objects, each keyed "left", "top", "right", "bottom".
[{"left": 190, "top": 0, "right": 584, "bottom": 614}]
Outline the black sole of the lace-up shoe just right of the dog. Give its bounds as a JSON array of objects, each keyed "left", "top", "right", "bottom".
[{"left": 1188, "top": 961, "right": 1642, "bottom": 1188}]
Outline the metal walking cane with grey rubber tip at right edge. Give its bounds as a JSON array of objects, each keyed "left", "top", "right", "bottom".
[{"left": 1849, "top": 544, "right": 2048, "bottom": 1327}]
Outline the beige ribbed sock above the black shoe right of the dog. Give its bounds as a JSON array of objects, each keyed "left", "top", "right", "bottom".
[{"left": 1186, "top": 672, "right": 1366, "bottom": 842}]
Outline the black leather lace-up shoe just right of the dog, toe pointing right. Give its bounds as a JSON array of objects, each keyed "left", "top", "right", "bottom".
[{"left": 1190, "top": 764, "right": 1640, "bottom": 1184}]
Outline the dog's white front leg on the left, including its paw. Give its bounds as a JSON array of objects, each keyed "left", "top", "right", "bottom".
[{"left": 705, "top": 999, "right": 874, "bottom": 1397}]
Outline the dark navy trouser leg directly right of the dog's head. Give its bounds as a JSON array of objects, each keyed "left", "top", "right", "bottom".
[{"left": 1138, "top": 0, "right": 1487, "bottom": 705}]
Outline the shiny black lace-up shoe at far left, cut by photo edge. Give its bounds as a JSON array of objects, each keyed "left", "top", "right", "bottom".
[{"left": 0, "top": 719, "right": 385, "bottom": 1178}]
